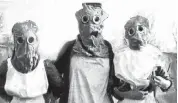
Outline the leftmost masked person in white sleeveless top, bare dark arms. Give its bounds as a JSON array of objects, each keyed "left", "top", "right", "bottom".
[{"left": 0, "top": 20, "right": 62, "bottom": 103}]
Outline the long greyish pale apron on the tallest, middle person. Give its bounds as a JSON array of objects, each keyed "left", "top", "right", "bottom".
[{"left": 68, "top": 55, "right": 110, "bottom": 103}]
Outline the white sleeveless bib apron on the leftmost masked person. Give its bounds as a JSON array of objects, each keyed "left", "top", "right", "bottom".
[{"left": 5, "top": 58, "right": 48, "bottom": 103}]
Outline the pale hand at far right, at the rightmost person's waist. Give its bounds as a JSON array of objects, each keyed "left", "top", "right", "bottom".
[{"left": 151, "top": 76, "right": 171, "bottom": 89}]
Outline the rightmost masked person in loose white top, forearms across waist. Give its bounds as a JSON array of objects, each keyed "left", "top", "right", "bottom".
[{"left": 114, "top": 15, "right": 172, "bottom": 103}]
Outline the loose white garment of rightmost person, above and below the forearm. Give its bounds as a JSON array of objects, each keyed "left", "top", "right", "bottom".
[{"left": 114, "top": 45, "right": 162, "bottom": 103}]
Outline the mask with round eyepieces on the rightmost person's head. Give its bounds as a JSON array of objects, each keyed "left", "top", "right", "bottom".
[{"left": 124, "top": 16, "right": 150, "bottom": 50}]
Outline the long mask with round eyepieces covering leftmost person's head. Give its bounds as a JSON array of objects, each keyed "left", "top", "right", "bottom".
[{"left": 12, "top": 20, "right": 39, "bottom": 73}]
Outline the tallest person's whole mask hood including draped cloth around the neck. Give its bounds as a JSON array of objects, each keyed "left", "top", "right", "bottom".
[{"left": 74, "top": 3, "right": 108, "bottom": 57}]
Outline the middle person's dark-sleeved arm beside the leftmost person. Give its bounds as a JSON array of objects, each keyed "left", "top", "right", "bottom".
[{"left": 49, "top": 40, "right": 75, "bottom": 98}]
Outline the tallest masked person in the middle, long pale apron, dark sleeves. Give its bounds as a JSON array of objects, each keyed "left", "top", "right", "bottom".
[{"left": 54, "top": 3, "right": 127, "bottom": 103}]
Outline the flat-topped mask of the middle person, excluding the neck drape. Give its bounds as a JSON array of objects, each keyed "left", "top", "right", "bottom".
[{"left": 76, "top": 3, "right": 108, "bottom": 47}]
